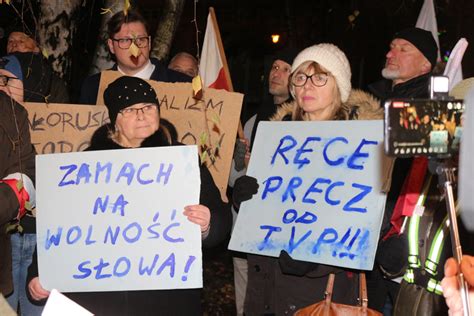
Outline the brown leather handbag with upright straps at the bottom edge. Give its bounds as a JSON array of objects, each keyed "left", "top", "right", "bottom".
[{"left": 294, "top": 272, "right": 382, "bottom": 316}]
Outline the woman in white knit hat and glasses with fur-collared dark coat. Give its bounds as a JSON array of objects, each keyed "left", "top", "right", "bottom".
[{"left": 245, "top": 44, "right": 383, "bottom": 315}]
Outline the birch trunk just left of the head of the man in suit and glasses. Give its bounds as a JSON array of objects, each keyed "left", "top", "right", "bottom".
[{"left": 89, "top": 0, "right": 125, "bottom": 75}]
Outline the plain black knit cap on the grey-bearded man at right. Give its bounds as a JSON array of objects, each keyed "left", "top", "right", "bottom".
[{"left": 393, "top": 27, "right": 438, "bottom": 69}]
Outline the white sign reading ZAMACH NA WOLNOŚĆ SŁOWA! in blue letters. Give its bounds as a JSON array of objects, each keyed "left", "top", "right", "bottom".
[{"left": 36, "top": 146, "right": 202, "bottom": 292}]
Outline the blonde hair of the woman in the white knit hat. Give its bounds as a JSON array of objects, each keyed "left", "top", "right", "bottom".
[{"left": 289, "top": 60, "right": 343, "bottom": 121}]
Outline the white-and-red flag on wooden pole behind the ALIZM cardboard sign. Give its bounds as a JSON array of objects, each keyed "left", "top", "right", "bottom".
[{"left": 199, "top": 7, "right": 234, "bottom": 91}]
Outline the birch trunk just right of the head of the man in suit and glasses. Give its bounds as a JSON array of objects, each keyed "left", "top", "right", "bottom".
[{"left": 150, "top": 0, "right": 185, "bottom": 60}]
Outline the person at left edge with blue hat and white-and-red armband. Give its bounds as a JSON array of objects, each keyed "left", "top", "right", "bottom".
[{"left": 0, "top": 59, "right": 38, "bottom": 316}]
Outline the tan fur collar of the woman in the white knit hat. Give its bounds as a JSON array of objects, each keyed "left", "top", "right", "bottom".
[{"left": 270, "top": 90, "right": 383, "bottom": 121}]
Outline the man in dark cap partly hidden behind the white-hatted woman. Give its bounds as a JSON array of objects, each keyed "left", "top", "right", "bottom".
[{"left": 229, "top": 48, "right": 297, "bottom": 315}]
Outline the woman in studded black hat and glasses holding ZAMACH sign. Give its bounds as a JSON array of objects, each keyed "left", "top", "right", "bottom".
[{"left": 29, "top": 76, "right": 231, "bottom": 316}]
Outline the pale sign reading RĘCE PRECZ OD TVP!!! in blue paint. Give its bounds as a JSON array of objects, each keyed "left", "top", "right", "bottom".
[{"left": 229, "top": 121, "right": 386, "bottom": 270}]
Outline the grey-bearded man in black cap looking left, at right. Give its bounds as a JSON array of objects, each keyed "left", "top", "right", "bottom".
[{"left": 369, "top": 27, "right": 438, "bottom": 101}]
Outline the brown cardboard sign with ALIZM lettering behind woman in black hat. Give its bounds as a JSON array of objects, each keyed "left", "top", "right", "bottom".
[{"left": 97, "top": 71, "right": 243, "bottom": 201}]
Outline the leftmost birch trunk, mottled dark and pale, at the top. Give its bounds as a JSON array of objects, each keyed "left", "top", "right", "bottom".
[{"left": 38, "top": 0, "right": 82, "bottom": 78}]
